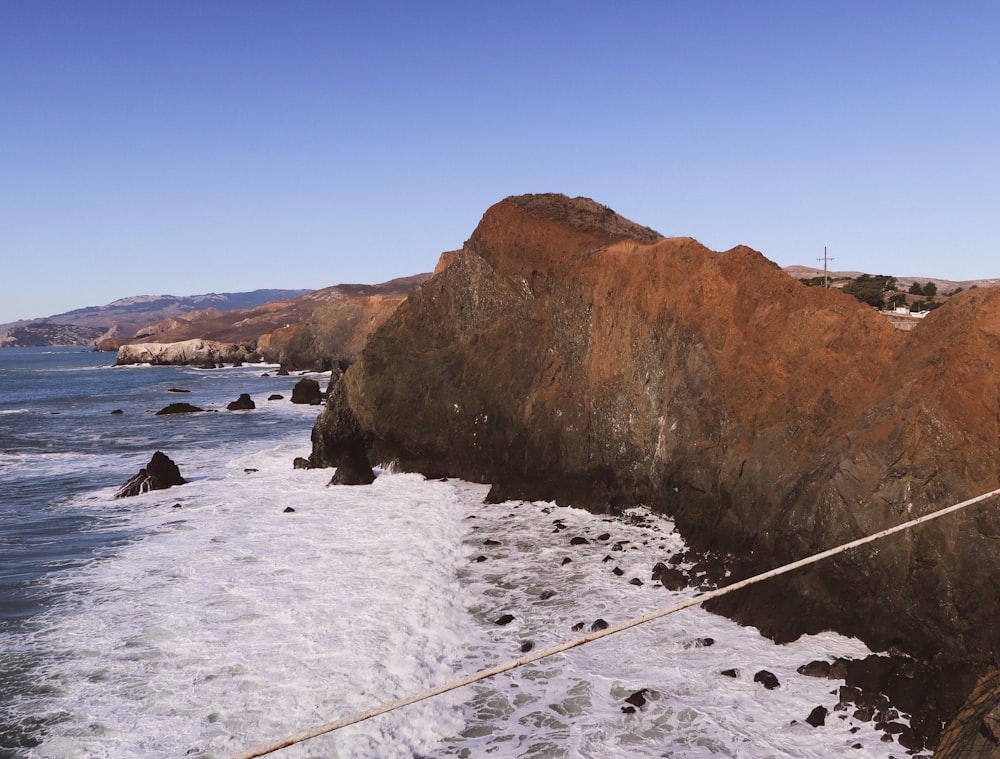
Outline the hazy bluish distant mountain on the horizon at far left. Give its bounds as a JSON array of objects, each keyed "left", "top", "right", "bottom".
[{"left": 0, "top": 289, "right": 313, "bottom": 347}]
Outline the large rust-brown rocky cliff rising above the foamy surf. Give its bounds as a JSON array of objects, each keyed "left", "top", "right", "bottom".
[{"left": 313, "top": 195, "right": 1000, "bottom": 736}]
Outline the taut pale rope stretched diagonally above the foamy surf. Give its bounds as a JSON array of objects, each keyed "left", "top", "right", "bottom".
[{"left": 230, "top": 488, "right": 1000, "bottom": 759}]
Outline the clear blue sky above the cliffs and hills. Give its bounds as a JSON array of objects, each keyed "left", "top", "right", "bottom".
[{"left": 0, "top": 0, "right": 1000, "bottom": 323}]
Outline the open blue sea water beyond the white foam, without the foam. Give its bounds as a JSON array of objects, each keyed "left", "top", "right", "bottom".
[{"left": 0, "top": 347, "right": 315, "bottom": 756}]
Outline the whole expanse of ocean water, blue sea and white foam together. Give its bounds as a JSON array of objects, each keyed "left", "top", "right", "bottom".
[{"left": 0, "top": 349, "right": 905, "bottom": 759}]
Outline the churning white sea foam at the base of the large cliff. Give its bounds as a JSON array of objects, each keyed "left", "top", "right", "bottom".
[{"left": 13, "top": 439, "right": 900, "bottom": 759}]
